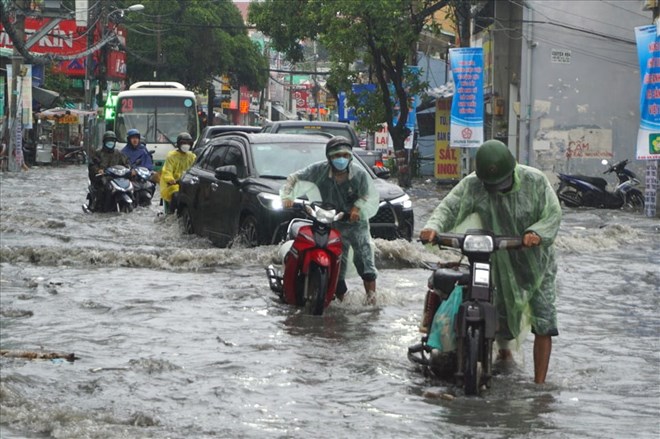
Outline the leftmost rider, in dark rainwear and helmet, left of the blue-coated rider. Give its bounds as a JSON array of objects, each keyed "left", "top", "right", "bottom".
[{"left": 83, "top": 131, "right": 130, "bottom": 212}]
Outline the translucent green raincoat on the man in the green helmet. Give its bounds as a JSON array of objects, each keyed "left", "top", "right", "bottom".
[{"left": 424, "top": 164, "right": 561, "bottom": 340}]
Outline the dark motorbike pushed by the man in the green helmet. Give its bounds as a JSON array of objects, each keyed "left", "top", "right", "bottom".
[{"left": 408, "top": 229, "right": 522, "bottom": 395}]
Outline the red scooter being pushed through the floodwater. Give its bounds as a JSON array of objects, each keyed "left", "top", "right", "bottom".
[{"left": 266, "top": 202, "right": 344, "bottom": 315}]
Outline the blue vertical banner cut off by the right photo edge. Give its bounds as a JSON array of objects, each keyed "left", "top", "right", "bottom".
[{"left": 635, "top": 25, "right": 660, "bottom": 160}]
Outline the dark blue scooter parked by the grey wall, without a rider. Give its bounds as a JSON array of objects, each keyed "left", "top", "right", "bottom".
[{"left": 557, "top": 159, "right": 644, "bottom": 211}]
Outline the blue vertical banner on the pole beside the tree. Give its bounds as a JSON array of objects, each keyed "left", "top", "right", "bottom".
[{"left": 449, "top": 47, "right": 484, "bottom": 148}]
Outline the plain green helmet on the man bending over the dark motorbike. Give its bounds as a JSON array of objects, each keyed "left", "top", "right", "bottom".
[{"left": 477, "top": 140, "right": 516, "bottom": 192}]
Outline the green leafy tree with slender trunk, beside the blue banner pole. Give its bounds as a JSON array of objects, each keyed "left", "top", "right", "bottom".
[{"left": 250, "top": 0, "right": 452, "bottom": 186}]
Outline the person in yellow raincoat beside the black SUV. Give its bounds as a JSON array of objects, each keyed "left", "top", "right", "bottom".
[{"left": 160, "top": 132, "right": 197, "bottom": 213}]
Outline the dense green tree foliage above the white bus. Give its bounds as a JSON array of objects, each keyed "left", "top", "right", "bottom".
[{"left": 118, "top": 0, "right": 268, "bottom": 90}]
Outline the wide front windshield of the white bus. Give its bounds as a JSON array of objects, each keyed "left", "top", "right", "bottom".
[{"left": 115, "top": 96, "right": 198, "bottom": 144}]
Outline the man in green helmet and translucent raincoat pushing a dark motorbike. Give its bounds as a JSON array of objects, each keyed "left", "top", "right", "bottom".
[{"left": 420, "top": 140, "right": 561, "bottom": 384}]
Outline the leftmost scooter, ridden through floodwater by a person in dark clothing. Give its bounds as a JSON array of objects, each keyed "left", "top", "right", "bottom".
[{"left": 82, "top": 165, "right": 134, "bottom": 213}]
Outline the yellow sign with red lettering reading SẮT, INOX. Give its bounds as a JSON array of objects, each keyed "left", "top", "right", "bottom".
[{"left": 435, "top": 99, "right": 461, "bottom": 180}]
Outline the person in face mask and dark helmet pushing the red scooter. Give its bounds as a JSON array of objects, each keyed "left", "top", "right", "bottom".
[{"left": 280, "top": 136, "right": 380, "bottom": 304}]
